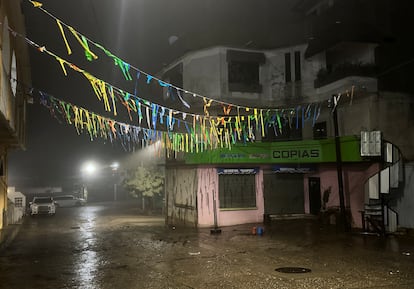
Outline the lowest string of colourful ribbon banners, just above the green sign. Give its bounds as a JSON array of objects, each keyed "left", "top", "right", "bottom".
[{"left": 39, "top": 91, "right": 324, "bottom": 155}]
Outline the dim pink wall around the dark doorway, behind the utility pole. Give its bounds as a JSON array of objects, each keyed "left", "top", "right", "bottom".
[{"left": 304, "top": 163, "right": 379, "bottom": 228}]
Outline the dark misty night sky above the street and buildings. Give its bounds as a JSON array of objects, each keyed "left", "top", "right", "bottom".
[{"left": 7, "top": 0, "right": 304, "bottom": 189}]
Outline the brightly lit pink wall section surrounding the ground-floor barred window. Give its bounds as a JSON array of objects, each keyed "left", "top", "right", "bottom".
[{"left": 197, "top": 168, "right": 264, "bottom": 227}]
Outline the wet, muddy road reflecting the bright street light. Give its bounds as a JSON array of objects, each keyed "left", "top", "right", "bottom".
[{"left": 0, "top": 203, "right": 414, "bottom": 289}]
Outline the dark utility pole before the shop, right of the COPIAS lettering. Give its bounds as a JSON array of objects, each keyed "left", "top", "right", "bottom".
[{"left": 329, "top": 94, "right": 349, "bottom": 232}]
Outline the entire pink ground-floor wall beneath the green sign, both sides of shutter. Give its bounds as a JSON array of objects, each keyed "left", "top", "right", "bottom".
[{"left": 197, "top": 163, "right": 380, "bottom": 228}]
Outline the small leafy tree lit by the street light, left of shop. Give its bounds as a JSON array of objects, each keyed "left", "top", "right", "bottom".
[{"left": 123, "top": 165, "right": 165, "bottom": 210}]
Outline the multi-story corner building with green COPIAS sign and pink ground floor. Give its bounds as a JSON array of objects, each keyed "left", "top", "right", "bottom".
[{"left": 160, "top": 0, "right": 414, "bottom": 230}]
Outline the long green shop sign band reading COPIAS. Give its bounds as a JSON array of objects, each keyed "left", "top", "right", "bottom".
[{"left": 184, "top": 136, "right": 362, "bottom": 164}]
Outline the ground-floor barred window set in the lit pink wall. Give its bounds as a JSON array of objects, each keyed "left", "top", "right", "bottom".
[{"left": 219, "top": 174, "right": 256, "bottom": 209}]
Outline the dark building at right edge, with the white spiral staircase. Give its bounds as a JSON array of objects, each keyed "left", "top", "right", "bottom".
[{"left": 296, "top": 0, "right": 414, "bottom": 227}]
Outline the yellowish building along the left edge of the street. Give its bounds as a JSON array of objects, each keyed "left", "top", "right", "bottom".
[{"left": 0, "top": 1, "right": 31, "bottom": 229}]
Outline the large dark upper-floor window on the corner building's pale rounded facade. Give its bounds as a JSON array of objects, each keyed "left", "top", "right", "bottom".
[{"left": 227, "top": 50, "right": 265, "bottom": 93}]
